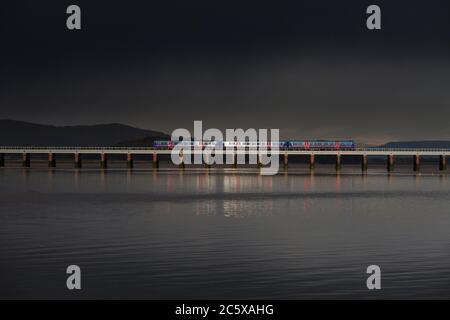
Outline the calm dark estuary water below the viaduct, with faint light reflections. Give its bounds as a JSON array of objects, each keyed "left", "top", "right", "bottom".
[{"left": 0, "top": 167, "right": 450, "bottom": 299}]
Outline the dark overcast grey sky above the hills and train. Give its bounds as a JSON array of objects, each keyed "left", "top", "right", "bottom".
[{"left": 0, "top": 0, "right": 450, "bottom": 142}]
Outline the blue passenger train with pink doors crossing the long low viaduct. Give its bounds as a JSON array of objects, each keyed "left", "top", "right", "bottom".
[{"left": 153, "top": 140, "right": 356, "bottom": 150}]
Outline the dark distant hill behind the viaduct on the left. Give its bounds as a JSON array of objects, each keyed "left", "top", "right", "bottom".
[{"left": 0, "top": 120, "right": 169, "bottom": 147}]
